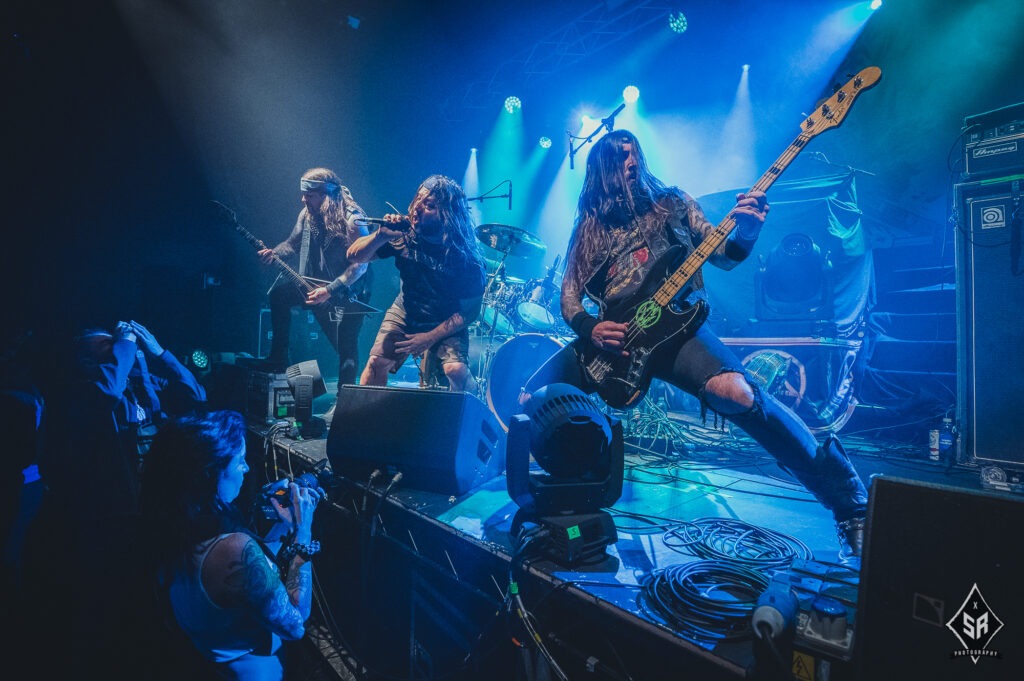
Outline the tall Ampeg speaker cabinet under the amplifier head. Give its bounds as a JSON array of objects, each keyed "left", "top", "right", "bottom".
[{"left": 955, "top": 178, "right": 1024, "bottom": 466}]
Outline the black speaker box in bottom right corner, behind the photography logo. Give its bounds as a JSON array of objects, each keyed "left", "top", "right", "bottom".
[{"left": 854, "top": 476, "right": 1024, "bottom": 681}]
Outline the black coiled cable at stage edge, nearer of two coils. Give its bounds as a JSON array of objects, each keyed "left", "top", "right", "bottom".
[{"left": 637, "top": 560, "right": 769, "bottom": 644}]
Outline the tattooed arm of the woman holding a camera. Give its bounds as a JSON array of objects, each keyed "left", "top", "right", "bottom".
[{"left": 203, "top": 533, "right": 312, "bottom": 639}]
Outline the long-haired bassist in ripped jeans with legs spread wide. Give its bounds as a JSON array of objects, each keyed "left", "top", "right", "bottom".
[{"left": 520, "top": 130, "right": 867, "bottom": 559}]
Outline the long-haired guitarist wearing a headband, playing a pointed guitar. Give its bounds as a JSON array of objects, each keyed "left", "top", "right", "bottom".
[{"left": 257, "top": 168, "right": 371, "bottom": 386}]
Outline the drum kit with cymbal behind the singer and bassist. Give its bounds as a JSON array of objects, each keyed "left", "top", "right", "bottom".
[{"left": 470, "top": 224, "right": 572, "bottom": 429}]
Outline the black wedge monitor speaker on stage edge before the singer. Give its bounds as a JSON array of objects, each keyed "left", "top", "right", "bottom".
[{"left": 327, "top": 385, "right": 505, "bottom": 495}]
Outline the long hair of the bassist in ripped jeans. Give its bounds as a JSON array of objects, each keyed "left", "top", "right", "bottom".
[{"left": 568, "top": 130, "right": 678, "bottom": 274}]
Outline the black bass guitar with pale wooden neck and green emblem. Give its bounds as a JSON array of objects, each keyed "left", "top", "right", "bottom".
[{"left": 577, "top": 67, "right": 882, "bottom": 409}]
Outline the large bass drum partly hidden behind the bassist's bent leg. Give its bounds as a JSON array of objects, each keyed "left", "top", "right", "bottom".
[{"left": 487, "top": 334, "right": 564, "bottom": 430}]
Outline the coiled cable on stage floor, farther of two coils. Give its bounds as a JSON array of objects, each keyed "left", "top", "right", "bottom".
[{"left": 663, "top": 518, "right": 814, "bottom": 571}]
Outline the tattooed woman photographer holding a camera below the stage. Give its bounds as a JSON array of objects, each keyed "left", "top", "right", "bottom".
[{"left": 142, "top": 412, "right": 326, "bottom": 681}]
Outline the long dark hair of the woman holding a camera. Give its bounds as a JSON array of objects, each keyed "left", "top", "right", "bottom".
[{"left": 141, "top": 411, "right": 247, "bottom": 566}]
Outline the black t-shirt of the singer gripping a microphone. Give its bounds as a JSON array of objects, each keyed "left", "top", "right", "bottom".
[{"left": 377, "top": 238, "right": 484, "bottom": 333}]
